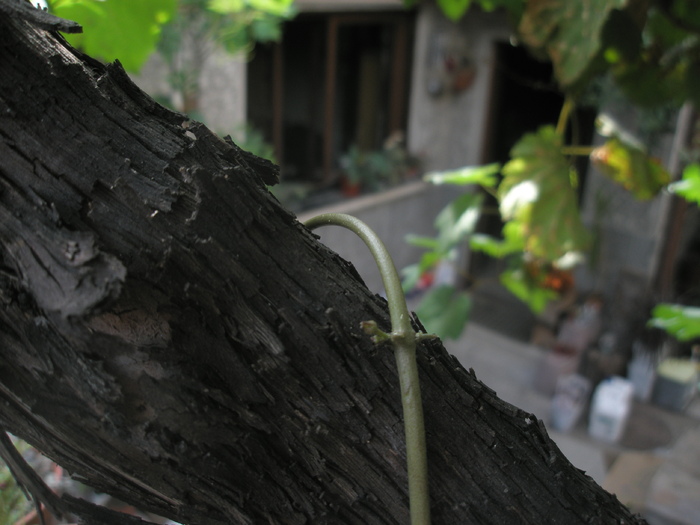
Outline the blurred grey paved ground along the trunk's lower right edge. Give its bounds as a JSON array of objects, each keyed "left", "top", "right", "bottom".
[{"left": 446, "top": 323, "right": 700, "bottom": 525}]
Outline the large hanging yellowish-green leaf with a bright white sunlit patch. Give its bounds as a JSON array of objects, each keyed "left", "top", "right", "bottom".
[{"left": 498, "top": 126, "right": 590, "bottom": 261}]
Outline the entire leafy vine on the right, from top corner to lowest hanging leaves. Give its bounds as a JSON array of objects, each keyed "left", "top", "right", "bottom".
[{"left": 404, "top": 0, "right": 700, "bottom": 337}]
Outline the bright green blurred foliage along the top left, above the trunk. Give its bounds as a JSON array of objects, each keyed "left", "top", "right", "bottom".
[{"left": 47, "top": 0, "right": 296, "bottom": 126}]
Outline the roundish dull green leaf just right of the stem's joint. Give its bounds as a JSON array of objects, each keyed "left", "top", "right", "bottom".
[{"left": 416, "top": 284, "right": 472, "bottom": 339}]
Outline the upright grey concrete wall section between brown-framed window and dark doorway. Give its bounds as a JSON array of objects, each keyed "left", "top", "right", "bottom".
[{"left": 408, "top": 4, "right": 511, "bottom": 171}]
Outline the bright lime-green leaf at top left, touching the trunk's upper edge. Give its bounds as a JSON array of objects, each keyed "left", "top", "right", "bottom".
[{"left": 48, "top": 0, "right": 177, "bottom": 72}]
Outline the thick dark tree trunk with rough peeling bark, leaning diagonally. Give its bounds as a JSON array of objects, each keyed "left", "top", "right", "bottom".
[{"left": 0, "top": 5, "right": 641, "bottom": 525}]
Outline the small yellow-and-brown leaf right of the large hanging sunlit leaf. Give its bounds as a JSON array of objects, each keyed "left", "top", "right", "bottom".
[{"left": 591, "top": 137, "right": 671, "bottom": 200}]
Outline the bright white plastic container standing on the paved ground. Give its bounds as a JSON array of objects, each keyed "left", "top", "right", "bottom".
[{"left": 588, "top": 377, "right": 634, "bottom": 443}]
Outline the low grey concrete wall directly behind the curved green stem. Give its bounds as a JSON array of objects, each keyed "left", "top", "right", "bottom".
[{"left": 299, "top": 182, "right": 464, "bottom": 293}]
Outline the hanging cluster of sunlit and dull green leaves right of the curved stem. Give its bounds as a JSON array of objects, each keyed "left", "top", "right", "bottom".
[{"left": 403, "top": 126, "right": 590, "bottom": 337}]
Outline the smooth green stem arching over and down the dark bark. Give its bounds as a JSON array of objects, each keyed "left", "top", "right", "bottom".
[{"left": 306, "top": 213, "right": 430, "bottom": 525}]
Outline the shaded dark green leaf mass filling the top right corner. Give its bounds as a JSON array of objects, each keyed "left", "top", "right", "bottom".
[{"left": 504, "top": 0, "right": 700, "bottom": 106}]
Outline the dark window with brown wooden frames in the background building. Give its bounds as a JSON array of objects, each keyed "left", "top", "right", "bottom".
[{"left": 248, "top": 12, "right": 412, "bottom": 185}]
